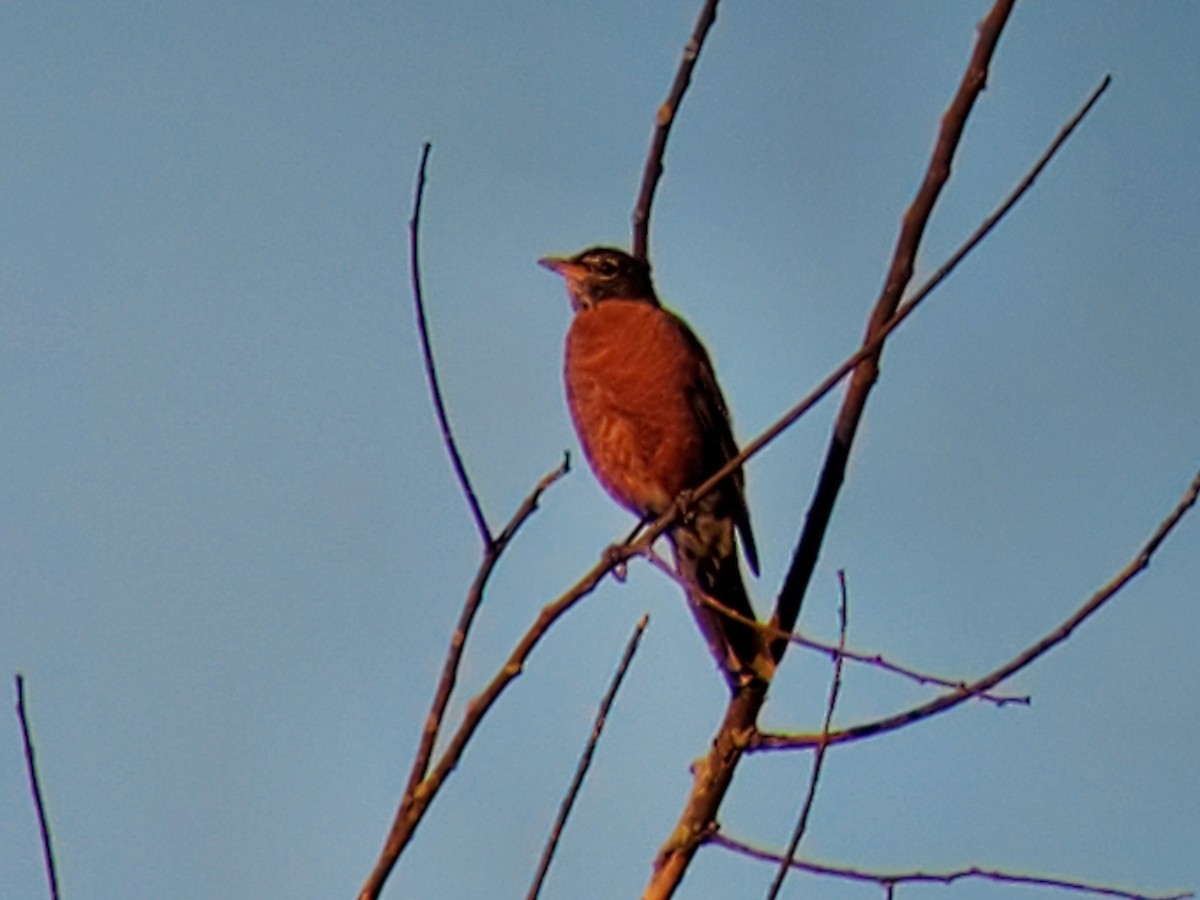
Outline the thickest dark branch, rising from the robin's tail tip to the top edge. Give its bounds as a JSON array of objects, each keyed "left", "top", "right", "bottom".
[{"left": 772, "top": 0, "right": 1015, "bottom": 661}]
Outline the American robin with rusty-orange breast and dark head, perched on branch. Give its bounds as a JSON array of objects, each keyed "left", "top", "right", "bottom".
[{"left": 539, "top": 247, "right": 770, "bottom": 688}]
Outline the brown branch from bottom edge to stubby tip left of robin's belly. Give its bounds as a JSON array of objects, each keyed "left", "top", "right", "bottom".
[{"left": 359, "top": 455, "right": 570, "bottom": 900}]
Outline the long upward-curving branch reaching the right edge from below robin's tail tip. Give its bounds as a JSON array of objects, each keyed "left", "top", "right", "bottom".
[{"left": 750, "top": 472, "right": 1200, "bottom": 751}]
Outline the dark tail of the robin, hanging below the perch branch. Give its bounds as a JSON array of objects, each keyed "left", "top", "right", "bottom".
[{"left": 670, "top": 515, "right": 773, "bottom": 688}]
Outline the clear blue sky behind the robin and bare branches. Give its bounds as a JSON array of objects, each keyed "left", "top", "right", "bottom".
[{"left": 0, "top": 0, "right": 1200, "bottom": 900}]
